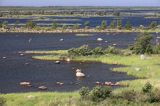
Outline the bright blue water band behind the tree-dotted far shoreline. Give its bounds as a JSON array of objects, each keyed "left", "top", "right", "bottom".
[{"left": 0, "top": 16, "right": 160, "bottom": 27}]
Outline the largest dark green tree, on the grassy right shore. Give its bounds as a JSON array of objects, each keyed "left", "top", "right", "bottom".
[{"left": 131, "top": 33, "right": 153, "bottom": 54}]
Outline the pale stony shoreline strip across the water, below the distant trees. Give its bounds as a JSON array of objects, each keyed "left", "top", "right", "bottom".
[{"left": 0, "top": 28, "right": 160, "bottom": 33}]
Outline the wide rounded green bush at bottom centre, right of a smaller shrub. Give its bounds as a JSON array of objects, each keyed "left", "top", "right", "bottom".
[{"left": 90, "top": 86, "right": 111, "bottom": 102}]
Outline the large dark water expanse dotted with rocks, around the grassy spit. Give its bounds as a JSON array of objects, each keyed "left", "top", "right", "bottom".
[{"left": 0, "top": 33, "right": 140, "bottom": 93}]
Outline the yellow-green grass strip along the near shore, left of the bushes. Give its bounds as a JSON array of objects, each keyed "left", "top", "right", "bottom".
[{"left": 0, "top": 92, "right": 80, "bottom": 106}]
